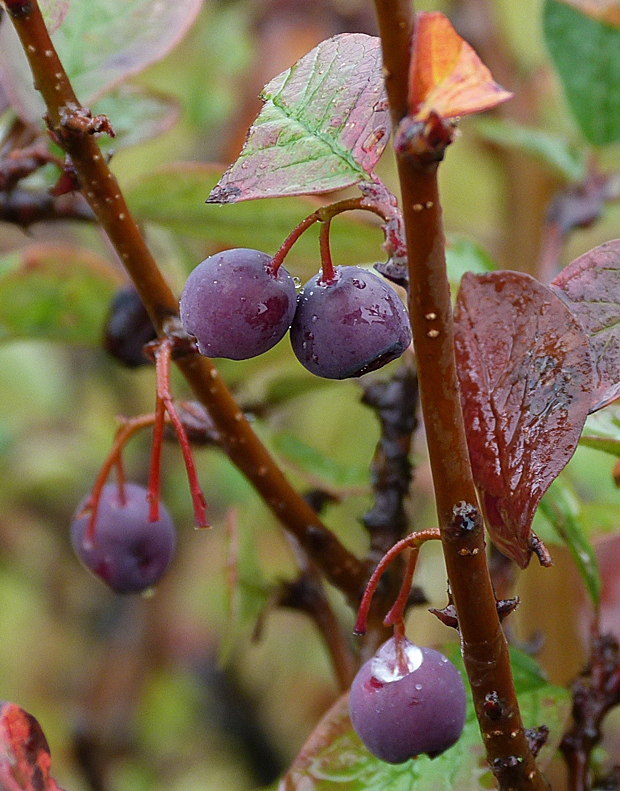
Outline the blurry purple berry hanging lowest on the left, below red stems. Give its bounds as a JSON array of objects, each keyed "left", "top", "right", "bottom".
[{"left": 71, "top": 483, "right": 176, "bottom": 593}]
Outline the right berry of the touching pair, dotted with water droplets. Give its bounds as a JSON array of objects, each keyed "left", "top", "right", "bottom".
[{"left": 291, "top": 266, "right": 411, "bottom": 379}]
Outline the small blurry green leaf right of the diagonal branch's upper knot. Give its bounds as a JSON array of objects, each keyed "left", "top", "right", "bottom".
[{"left": 92, "top": 84, "right": 180, "bottom": 151}]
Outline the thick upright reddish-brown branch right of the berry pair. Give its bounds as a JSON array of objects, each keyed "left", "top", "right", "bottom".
[{"left": 375, "top": 0, "right": 548, "bottom": 791}]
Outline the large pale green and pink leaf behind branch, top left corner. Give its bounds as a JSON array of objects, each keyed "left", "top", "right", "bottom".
[{"left": 0, "top": 0, "right": 202, "bottom": 123}]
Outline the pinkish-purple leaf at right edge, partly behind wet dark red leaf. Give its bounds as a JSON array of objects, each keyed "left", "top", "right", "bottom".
[{"left": 550, "top": 239, "right": 620, "bottom": 412}]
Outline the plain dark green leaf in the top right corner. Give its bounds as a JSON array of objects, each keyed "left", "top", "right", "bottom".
[{"left": 544, "top": 0, "right": 620, "bottom": 146}]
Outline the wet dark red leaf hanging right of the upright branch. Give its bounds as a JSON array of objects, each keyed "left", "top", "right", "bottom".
[{"left": 455, "top": 272, "right": 593, "bottom": 568}]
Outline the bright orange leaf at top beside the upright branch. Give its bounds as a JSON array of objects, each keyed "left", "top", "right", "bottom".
[{"left": 409, "top": 12, "right": 512, "bottom": 121}]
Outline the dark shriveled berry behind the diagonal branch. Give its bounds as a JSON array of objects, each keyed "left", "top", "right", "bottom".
[{"left": 103, "top": 286, "right": 157, "bottom": 368}]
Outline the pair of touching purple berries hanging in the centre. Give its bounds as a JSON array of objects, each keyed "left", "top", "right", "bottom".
[{"left": 181, "top": 248, "right": 411, "bottom": 379}]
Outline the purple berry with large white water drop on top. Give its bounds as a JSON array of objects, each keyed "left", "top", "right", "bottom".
[{"left": 349, "top": 638, "right": 466, "bottom": 764}]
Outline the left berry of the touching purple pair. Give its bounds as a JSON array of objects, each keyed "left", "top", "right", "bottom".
[{"left": 181, "top": 247, "right": 296, "bottom": 360}]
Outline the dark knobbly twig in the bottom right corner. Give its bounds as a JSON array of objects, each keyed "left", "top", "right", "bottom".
[{"left": 560, "top": 631, "right": 620, "bottom": 791}]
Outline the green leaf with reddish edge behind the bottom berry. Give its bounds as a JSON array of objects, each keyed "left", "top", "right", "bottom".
[{"left": 279, "top": 647, "right": 571, "bottom": 791}]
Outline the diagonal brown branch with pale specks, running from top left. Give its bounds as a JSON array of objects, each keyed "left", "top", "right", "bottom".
[{"left": 4, "top": 0, "right": 368, "bottom": 617}]
